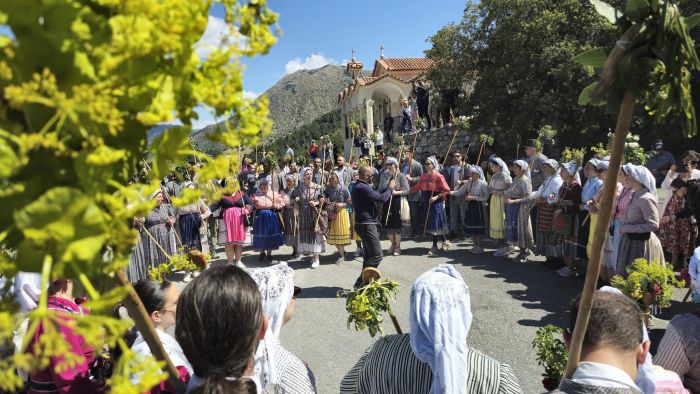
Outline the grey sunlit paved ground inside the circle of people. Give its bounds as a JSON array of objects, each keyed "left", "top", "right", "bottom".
[{"left": 175, "top": 237, "right": 692, "bottom": 394}]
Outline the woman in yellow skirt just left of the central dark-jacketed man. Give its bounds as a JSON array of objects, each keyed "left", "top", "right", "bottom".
[{"left": 323, "top": 171, "right": 351, "bottom": 263}]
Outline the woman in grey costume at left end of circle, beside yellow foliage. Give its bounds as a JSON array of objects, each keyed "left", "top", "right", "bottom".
[{"left": 142, "top": 189, "right": 177, "bottom": 267}]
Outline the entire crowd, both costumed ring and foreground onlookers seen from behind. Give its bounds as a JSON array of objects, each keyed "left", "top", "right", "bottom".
[{"left": 6, "top": 136, "right": 700, "bottom": 394}]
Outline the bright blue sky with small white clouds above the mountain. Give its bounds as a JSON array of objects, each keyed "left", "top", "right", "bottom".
[{"left": 0, "top": 0, "right": 466, "bottom": 129}]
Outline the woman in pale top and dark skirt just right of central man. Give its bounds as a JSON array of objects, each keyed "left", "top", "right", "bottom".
[{"left": 377, "top": 157, "right": 410, "bottom": 256}]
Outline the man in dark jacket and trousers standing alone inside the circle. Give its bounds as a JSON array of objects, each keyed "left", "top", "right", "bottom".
[{"left": 350, "top": 166, "right": 396, "bottom": 288}]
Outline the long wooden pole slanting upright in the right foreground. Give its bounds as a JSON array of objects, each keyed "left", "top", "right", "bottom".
[{"left": 565, "top": 91, "right": 634, "bottom": 378}]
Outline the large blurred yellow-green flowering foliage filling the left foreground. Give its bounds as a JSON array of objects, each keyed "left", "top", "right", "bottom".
[{"left": 0, "top": 0, "right": 277, "bottom": 393}]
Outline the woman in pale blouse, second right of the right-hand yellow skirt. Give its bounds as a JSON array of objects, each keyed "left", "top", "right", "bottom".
[{"left": 528, "top": 159, "right": 564, "bottom": 256}]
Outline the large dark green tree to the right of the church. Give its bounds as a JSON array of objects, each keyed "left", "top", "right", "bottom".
[{"left": 426, "top": 0, "right": 700, "bottom": 157}]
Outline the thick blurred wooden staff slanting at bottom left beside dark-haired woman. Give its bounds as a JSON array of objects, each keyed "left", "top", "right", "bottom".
[{"left": 116, "top": 271, "right": 187, "bottom": 393}]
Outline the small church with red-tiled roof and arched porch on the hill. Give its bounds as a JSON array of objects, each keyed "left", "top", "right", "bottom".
[{"left": 338, "top": 48, "right": 433, "bottom": 156}]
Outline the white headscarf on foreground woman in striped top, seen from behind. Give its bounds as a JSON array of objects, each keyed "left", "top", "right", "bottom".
[{"left": 409, "top": 264, "right": 472, "bottom": 394}]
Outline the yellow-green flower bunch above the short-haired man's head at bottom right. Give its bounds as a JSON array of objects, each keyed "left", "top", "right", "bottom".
[{"left": 610, "top": 259, "right": 685, "bottom": 308}]
